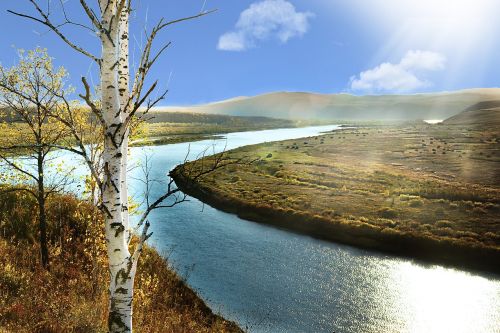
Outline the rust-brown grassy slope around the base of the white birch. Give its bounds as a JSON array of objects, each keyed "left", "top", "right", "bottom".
[{"left": 0, "top": 188, "right": 241, "bottom": 333}]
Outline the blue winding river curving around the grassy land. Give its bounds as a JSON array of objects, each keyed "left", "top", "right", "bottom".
[{"left": 124, "top": 126, "right": 500, "bottom": 333}]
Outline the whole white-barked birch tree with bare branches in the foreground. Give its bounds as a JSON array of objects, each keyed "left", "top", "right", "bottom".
[{"left": 10, "top": 0, "right": 215, "bottom": 332}]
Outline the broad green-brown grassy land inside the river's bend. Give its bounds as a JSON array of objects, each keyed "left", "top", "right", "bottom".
[{"left": 173, "top": 124, "right": 500, "bottom": 272}]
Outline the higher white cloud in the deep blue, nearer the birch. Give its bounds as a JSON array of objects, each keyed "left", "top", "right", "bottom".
[{"left": 217, "top": 0, "right": 313, "bottom": 51}]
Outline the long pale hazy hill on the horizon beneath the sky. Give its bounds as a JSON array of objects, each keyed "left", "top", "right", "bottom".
[{"left": 156, "top": 88, "right": 500, "bottom": 120}]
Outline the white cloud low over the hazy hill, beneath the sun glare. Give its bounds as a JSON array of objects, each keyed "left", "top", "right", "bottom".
[{"left": 350, "top": 50, "right": 446, "bottom": 92}]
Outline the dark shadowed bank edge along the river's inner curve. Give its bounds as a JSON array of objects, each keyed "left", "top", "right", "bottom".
[{"left": 170, "top": 166, "right": 500, "bottom": 275}]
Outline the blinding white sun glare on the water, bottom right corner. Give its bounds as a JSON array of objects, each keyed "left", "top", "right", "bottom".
[{"left": 384, "top": 262, "right": 500, "bottom": 333}]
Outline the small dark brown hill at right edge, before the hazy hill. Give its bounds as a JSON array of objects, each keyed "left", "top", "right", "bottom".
[{"left": 444, "top": 100, "right": 500, "bottom": 127}]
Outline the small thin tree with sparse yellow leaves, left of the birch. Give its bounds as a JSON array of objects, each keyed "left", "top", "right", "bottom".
[{"left": 0, "top": 48, "right": 74, "bottom": 269}]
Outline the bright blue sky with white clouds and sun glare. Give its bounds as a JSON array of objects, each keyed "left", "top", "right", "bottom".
[{"left": 0, "top": 0, "right": 500, "bottom": 105}]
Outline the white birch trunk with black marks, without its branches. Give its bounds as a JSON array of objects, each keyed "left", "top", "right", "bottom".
[{"left": 101, "top": 1, "right": 135, "bottom": 333}]
